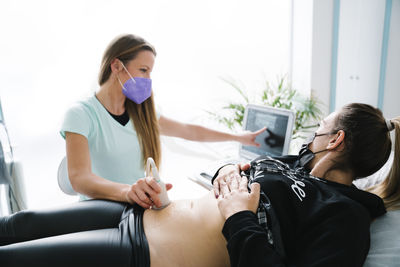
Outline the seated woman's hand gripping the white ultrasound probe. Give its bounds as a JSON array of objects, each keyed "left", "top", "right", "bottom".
[{"left": 125, "top": 177, "right": 172, "bottom": 209}]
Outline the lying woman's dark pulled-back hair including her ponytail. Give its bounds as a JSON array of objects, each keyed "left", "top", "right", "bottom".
[{"left": 333, "top": 103, "right": 400, "bottom": 210}]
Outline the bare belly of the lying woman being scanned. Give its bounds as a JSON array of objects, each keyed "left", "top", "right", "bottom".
[{"left": 143, "top": 193, "right": 229, "bottom": 267}]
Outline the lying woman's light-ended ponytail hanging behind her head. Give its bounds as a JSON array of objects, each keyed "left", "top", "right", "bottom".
[{"left": 369, "top": 117, "right": 400, "bottom": 211}]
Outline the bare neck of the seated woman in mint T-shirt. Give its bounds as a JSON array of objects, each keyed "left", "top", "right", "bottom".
[{"left": 96, "top": 79, "right": 126, "bottom": 115}]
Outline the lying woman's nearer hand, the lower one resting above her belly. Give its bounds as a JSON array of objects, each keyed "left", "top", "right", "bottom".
[{"left": 218, "top": 175, "right": 260, "bottom": 219}]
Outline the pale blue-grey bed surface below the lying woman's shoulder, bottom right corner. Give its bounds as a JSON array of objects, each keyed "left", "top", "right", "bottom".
[{"left": 364, "top": 210, "right": 400, "bottom": 267}]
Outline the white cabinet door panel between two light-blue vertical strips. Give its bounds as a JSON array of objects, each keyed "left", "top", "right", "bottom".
[{"left": 335, "top": 0, "right": 385, "bottom": 109}]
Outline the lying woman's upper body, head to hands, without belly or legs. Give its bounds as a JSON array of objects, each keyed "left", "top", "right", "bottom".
[{"left": 213, "top": 103, "right": 400, "bottom": 266}]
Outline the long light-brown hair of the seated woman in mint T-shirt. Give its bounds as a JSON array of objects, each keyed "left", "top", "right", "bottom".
[{"left": 99, "top": 34, "right": 161, "bottom": 169}]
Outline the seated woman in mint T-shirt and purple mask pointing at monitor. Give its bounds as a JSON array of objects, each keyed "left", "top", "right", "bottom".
[{"left": 61, "top": 35, "right": 265, "bottom": 208}]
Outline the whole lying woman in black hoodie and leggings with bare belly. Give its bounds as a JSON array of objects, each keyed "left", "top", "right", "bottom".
[{"left": 0, "top": 104, "right": 400, "bottom": 267}]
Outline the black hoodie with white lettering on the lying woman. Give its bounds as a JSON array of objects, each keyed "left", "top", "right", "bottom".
[{"left": 214, "top": 156, "right": 386, "bottom": 267}]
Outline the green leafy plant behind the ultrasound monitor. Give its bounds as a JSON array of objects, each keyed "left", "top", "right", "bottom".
[{"left": 207, "top": 76, "right": 322, "bottom": 146}]
